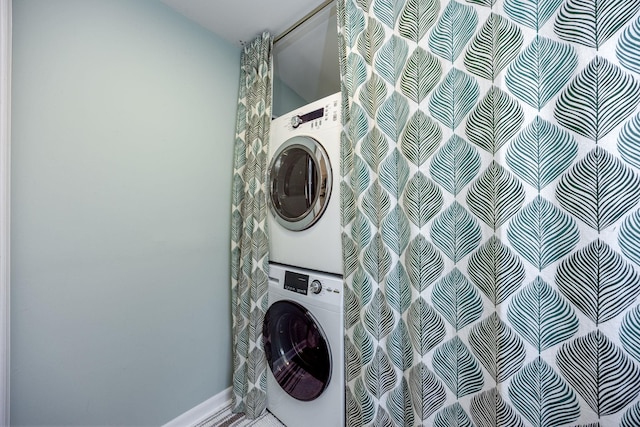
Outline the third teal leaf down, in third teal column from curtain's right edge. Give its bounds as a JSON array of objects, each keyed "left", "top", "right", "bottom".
[{"left": 429, "top": 134, "right": 480, "bottom": 196}]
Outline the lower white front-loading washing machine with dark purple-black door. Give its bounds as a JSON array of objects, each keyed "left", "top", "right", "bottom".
[{"left": 262, "top": 264, "right": 345, "bottom": 427}]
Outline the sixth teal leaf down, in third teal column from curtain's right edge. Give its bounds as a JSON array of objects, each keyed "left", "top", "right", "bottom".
[{"left": 432, "top": 336, "right": 484, "bottom": 399}]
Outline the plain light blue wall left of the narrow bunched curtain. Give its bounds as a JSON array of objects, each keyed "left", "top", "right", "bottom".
[{"left": 11, "top": 0, "right": 240, "bottom": 426}]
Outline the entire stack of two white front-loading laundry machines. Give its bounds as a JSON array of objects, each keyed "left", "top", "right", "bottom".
[{"left": 263, "top": 93, "right": 345, "bottom": 427}]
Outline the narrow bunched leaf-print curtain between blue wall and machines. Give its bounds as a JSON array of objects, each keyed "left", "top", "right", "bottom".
[{"left": 231, "top": 33, "right": 273, "bottom": 419}]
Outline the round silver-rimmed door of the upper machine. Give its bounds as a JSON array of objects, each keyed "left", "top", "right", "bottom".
[{"left": 269, "top": 136, "right": 332, "bottom": 231}]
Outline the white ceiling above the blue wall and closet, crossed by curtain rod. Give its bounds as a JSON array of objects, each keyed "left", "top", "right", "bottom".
[{"left": 162, "top": 0, "right": 340, "bottom": 103}]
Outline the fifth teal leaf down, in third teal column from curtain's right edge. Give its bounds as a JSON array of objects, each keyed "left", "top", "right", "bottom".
[{"left": 431, "top": 268, "right": 483, "bottom": 332}]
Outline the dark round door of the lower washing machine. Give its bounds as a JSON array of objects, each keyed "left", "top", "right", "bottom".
[{"left": 262, "top": 300, "right": 331, "bottom": 402}]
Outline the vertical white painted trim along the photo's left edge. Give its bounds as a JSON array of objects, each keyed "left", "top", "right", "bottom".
[{"left": 0, "top": 0, "right": 11, "bottom": 426}]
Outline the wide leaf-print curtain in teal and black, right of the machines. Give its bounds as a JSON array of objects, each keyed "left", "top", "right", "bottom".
[{"left": 338, "top": 0, "right": 640, "bottom": 427}]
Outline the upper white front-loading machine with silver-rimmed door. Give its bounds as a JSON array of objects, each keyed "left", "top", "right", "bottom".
[{"left": 268, "top": 93, "right": 342, "bottom": 274}]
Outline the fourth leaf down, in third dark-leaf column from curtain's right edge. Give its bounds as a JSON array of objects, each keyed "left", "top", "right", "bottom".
[{"left": 402, "top": 172, "right": 444, "bottom": 228}]
